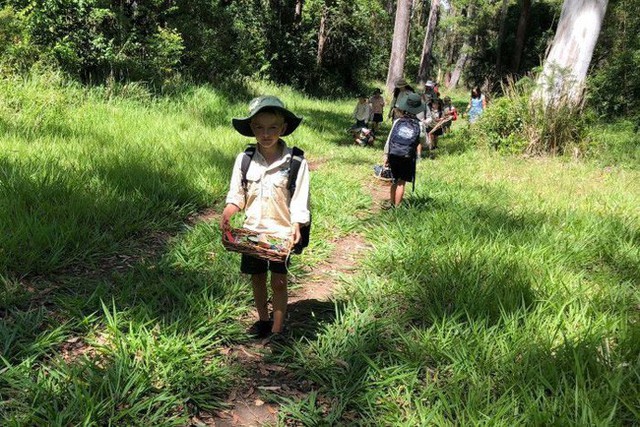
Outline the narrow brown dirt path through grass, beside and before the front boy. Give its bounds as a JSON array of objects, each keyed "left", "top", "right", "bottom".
[{"left": 198, "top": 176, "right": 389, "bottom": 427}]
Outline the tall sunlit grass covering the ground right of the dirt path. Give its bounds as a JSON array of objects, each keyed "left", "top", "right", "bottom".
[{"left": 280, "top": 150, "right": 640, "bottom": 425}]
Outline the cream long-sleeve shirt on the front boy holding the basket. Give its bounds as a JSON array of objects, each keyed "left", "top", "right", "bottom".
[{"left": 226, "top": 141, "right": 311, "bottom": 239}]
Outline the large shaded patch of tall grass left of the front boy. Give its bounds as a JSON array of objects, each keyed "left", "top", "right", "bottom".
[{"left": 0, "top": 127, "right": 234, "bottom": 277}]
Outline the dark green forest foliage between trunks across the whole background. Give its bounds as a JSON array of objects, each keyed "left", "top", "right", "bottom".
[{"left": 0, "top": 0, "right": 640, "bottom": 117}]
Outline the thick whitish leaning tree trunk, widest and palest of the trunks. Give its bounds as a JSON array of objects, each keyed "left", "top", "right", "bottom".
[{"left": 537, "top": 0, "right": 607, "bottom": 106}]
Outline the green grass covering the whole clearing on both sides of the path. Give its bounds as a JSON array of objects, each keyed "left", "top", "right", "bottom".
[{"left": 0, "top": 72, "right": 640, "bottom": 426}]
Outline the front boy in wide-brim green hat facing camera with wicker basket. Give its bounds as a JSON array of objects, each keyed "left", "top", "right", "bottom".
[{"left": 220, "top": 96, "right": 311, "bottom": 340}]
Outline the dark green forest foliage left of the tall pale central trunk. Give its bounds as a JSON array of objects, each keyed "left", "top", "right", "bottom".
[{"left": 0, "top": 0, "right": 393, "bottom": 94}]
